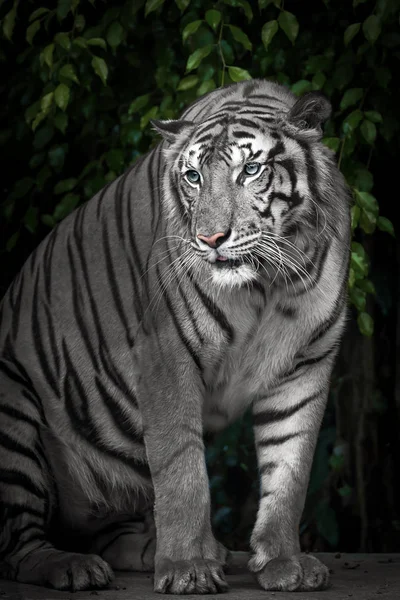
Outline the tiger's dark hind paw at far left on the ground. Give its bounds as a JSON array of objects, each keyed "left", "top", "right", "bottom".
[{"left": 18, "top": 550, "right": 114, "bottom": 592}]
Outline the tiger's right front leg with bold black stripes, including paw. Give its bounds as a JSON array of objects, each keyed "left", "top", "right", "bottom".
[{"left": 249, "top": 361, "right": 331, "bottom": 591}]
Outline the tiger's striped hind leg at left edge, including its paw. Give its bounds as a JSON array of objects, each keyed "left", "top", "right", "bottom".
[{"left": 0, "top": 361, "right": 113, "bottom": 591}]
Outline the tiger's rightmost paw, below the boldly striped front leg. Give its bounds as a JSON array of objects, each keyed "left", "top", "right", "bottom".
[{"left": 249, "top": 554, "right": 329, "bottom": 592}]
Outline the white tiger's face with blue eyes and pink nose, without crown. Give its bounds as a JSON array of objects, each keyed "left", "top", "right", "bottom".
[{"left": 155, "top": 89, "right": 329, "bottom": 286}]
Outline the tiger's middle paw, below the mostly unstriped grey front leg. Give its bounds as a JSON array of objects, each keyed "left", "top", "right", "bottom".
[{"left": 154, "top": 558, "right": 228, "bottom": 594}]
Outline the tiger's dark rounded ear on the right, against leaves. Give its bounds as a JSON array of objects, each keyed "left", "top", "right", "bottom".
[{"left": 286, "top": 92, "right": 332, "bottom": 133}]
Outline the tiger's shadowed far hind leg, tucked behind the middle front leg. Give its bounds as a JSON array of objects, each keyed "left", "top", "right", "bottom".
[{"left": 90, "top": 514, "right": 156, "bottom": 572}]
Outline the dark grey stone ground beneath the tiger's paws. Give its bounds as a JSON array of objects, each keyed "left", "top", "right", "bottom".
[{"left": 0, "top": 552, "right": 400, "bottom": 600}]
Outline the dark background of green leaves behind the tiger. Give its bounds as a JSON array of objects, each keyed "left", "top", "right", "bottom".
[{"left": 0, "top": 0, "right": 400, "bottom": 551}]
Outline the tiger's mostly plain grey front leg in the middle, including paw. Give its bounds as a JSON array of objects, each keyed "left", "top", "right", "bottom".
[{"left": 139, "top": 355, "right": 228, "bottom": 594}]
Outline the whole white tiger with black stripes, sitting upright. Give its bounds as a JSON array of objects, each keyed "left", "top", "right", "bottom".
[{"left": 0, "top": 80, "right": 350, "bottom": 594}]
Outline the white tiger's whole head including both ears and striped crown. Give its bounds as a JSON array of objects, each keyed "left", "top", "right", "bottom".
[{"left": 152, "top": 81, "right": 343, "bottom": 286}]
